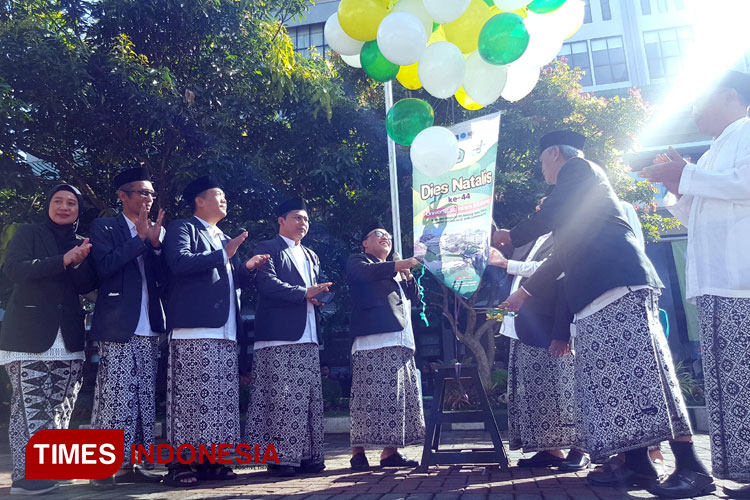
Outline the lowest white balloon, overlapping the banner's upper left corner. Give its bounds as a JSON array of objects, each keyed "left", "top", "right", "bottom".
[{"left": 409, "top": 127, "right": 458, "bottom": 177}]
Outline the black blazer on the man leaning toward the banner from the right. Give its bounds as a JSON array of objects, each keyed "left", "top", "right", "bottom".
[{"left": 510, "top": 158, "right": 663, "bottom": 312}]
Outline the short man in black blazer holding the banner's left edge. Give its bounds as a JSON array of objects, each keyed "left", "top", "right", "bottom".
[{"left": 346, "top": 221, "right": 425, "bottom": 470}]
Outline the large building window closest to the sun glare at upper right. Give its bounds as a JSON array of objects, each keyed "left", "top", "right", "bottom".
[{"left": 643, "top": 26, "right": 693, "bottom": 79}]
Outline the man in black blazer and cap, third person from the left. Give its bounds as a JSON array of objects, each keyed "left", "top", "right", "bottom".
[{"left": 164, "top": 176, "right": 268, "bottom": 486}]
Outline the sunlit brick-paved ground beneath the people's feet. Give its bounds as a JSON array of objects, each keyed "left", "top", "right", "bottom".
[{"left": 0, "top": 431, "right": 736, "bottom": 500}]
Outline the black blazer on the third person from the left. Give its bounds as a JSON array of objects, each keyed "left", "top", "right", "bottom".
[{"left": 162, "top": 217, "right": 254, "bottom": 332}]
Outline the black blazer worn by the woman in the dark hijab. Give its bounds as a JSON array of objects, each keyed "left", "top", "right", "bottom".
[{"left": 0, "top": 224, "right": 96, "bottom": 353}]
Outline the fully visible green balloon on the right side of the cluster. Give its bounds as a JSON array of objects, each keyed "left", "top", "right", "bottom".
[{"left": 479, "top": 12, "right": 529, "bottom": 65}]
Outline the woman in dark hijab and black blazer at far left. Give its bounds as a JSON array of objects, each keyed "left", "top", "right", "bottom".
[{"left": 0, "top": 184, "right": 96, "bottom": 495}]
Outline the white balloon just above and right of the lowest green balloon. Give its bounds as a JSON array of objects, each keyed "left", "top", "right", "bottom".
[{"left": 417, "top": 42, "right": 466, "bottom": 99}]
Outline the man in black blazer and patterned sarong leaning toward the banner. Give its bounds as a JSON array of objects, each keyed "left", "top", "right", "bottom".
[{"left": 493, "top": 131, "right": 713, "bottom": 496}]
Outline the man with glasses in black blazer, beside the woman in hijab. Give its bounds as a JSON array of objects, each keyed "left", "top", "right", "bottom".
[{"left": 89, "top": 168, "right": 167, "bottom": 488}]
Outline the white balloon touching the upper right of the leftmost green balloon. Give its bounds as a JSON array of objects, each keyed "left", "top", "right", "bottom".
[{"left": 378, "top": 12, "right": 427, "bottom": 66}]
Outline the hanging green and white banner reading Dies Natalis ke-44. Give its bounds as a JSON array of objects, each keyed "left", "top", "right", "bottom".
[{"left": 412, "top": 113, "right": 500, "bottom": 298}]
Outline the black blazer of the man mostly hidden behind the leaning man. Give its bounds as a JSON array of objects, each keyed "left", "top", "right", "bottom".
[{"left": 513, "top": 237, "right": 573, "bottom": 348}]
